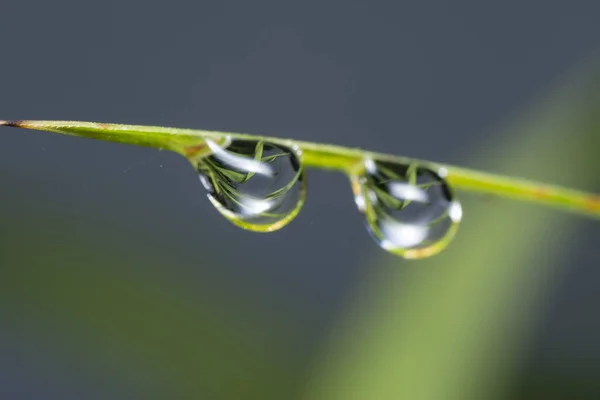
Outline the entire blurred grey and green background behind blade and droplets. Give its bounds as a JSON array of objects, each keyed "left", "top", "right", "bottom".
[{"left": 0, "top": 0, "right": 600, "bottom": 400}]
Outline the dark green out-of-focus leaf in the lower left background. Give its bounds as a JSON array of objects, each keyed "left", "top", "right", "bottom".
[{"left": 0, "top": 236, "right": 295, "bottom": 399}]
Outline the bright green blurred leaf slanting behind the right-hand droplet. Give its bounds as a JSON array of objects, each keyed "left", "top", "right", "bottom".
[{"left": 306, "top": 61, "right": 600, "bottom": 400}]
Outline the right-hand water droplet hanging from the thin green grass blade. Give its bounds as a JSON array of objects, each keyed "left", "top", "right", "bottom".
[{"left": 351, "top": 159, "right": 462, "bottom": 258}]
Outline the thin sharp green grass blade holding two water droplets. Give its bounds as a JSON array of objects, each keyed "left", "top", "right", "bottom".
[{"left": 0, "top": 120, "right": 600, "bottom": 218}]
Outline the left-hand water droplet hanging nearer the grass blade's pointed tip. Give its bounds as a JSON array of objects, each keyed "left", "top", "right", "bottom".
[{"left": 197, "top": 139, "right": 306, "bottom": 232}]
